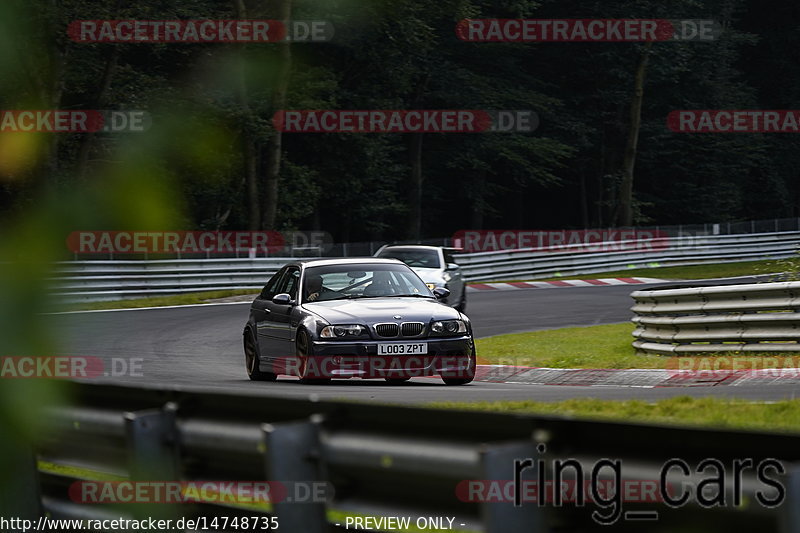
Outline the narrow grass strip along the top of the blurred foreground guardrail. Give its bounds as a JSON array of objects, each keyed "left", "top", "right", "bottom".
[{"left": 427, "top": 396, "right": 800, "bottom": 432}]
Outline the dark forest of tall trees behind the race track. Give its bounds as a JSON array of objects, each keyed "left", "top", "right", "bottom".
[{"left": 0, "top": 0, "right": 800, "bottom": 242}]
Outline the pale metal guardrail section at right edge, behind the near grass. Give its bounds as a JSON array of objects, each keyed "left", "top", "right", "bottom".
[{"left": 631, "top": 281, "right": 800, "bottom": 355}]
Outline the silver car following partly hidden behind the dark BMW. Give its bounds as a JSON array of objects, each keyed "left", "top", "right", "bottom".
[{"left": 375, "top": 244, "right": 467, "bottom": 311}]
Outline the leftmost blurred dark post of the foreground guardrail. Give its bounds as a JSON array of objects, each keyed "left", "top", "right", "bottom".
[{"left": 124, "top": 402, "right": 180, "bottom": 481}]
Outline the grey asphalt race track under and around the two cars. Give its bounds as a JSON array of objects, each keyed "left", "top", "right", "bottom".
[{"left": 53, "top": 278, "right": 800, "bottom": 403}]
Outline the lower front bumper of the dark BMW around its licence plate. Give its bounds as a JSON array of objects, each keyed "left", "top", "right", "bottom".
[{"left": 306, "top": 335, "right": 475, "bottom": 379}]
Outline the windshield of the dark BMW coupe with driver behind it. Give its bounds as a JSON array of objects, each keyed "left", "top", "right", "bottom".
[{"left": 303, "top": 263, "right": 434, "bottom": 302}]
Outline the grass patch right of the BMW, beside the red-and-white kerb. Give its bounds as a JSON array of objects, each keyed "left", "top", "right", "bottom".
[{"left": 475, "top": 322, "right": 671, "bottom": 368}]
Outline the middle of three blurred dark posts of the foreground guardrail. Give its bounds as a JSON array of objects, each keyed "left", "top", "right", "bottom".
[{"left": 261, "top": 415, "right": 328, "bottom": 533}]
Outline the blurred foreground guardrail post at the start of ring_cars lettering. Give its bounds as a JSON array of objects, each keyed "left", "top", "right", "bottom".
[{"left": 481, "top": 442, "right": 547, "bottom": 533}]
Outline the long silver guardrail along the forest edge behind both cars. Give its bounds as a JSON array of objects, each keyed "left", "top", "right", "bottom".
[{"left": 50, "top": 231, "right": 800, "bottom": 301}]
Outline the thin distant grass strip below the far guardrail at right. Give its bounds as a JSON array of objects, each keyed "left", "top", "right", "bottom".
[{"left": 482, "top": 261, "right": 786, "bottom": 283}]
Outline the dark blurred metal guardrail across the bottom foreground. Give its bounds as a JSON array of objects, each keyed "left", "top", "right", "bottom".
[{"left": 9, "top": 384, "right": 800, "bottom": 533}]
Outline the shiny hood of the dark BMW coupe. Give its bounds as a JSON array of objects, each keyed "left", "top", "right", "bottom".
[{"left": 303, "top": 297, "right": 460, "bottom": 324}]
